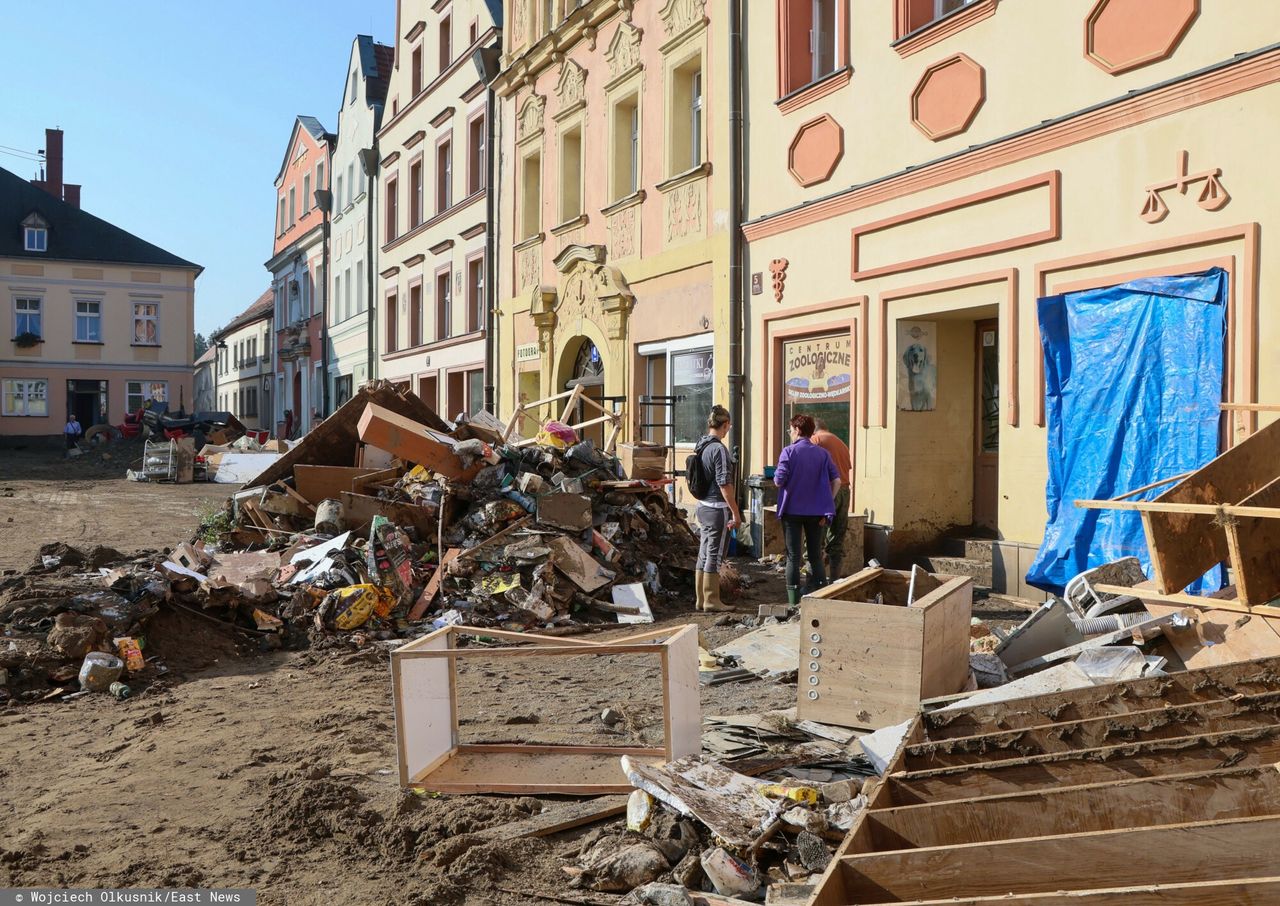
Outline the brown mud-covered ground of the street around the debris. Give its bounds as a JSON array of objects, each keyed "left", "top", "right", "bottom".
[{"left": 0, "top": 450, "right": 795, "bottom": 906}]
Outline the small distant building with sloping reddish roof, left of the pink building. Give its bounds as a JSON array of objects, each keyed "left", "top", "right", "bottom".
[{"left": 209, "top": 289, "right": 276, "bottom": 431}]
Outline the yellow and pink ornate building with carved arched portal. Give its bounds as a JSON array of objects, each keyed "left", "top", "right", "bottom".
[{"left": 494, "top": 0, "right": 733, "bottom": 447}]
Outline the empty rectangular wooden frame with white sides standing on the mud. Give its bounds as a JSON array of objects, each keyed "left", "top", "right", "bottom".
[{"left": 392, "top": 626, "right": 701, "bottom": 795}]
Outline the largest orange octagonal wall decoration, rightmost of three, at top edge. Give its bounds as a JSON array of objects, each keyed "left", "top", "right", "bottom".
[{"left": 1084, "top": 0, "right": 1199, "bottom": 76}]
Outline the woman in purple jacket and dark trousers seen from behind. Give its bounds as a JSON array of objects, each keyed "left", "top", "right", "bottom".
[{"left": 773, "top": 415, "right": 840, "bottom": 605}]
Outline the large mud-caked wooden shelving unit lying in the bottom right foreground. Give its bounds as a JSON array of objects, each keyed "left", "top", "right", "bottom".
[{"left": 808, "top": 658, "right": 1280, "bottom": 906}]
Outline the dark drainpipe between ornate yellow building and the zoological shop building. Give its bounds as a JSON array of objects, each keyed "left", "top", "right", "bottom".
[{"left": 728, "top": 0, "right": 750, "bottom": 484}]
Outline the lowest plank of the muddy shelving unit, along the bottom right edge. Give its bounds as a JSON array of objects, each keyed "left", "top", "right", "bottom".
[{"left": 873, "top": 875, "right": 1280, "bottom": 906}]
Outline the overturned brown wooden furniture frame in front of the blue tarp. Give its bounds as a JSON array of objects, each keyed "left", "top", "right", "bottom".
[{"left": 1075, "top": 414, "right": 1280, "bottom": 612}]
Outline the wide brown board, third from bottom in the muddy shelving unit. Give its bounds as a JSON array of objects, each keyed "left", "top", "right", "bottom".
[{"left": 869, "top": 765, "right": 1280, "bottom": 851}]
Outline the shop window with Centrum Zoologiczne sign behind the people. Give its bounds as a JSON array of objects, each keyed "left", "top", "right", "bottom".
[{"left": 777, "top": 333, "right": 854, "bottom": 449}]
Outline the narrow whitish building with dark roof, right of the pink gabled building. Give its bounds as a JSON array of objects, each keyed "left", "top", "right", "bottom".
[{"left": 325, "top": 35, "right": 396, "bottom": 411}]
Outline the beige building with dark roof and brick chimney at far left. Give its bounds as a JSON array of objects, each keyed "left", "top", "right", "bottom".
[{"left": 0, "top": 131, "right": 201, "bottom": 436}]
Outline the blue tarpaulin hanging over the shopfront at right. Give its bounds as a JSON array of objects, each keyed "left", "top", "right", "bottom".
[{"left": 1027, "top": 267, "right": 1228, "bottom": 594}]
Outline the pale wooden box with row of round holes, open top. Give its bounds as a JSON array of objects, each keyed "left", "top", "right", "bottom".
[{"left": 796, "top": 568, "right": 973, "bottom": 729}]
